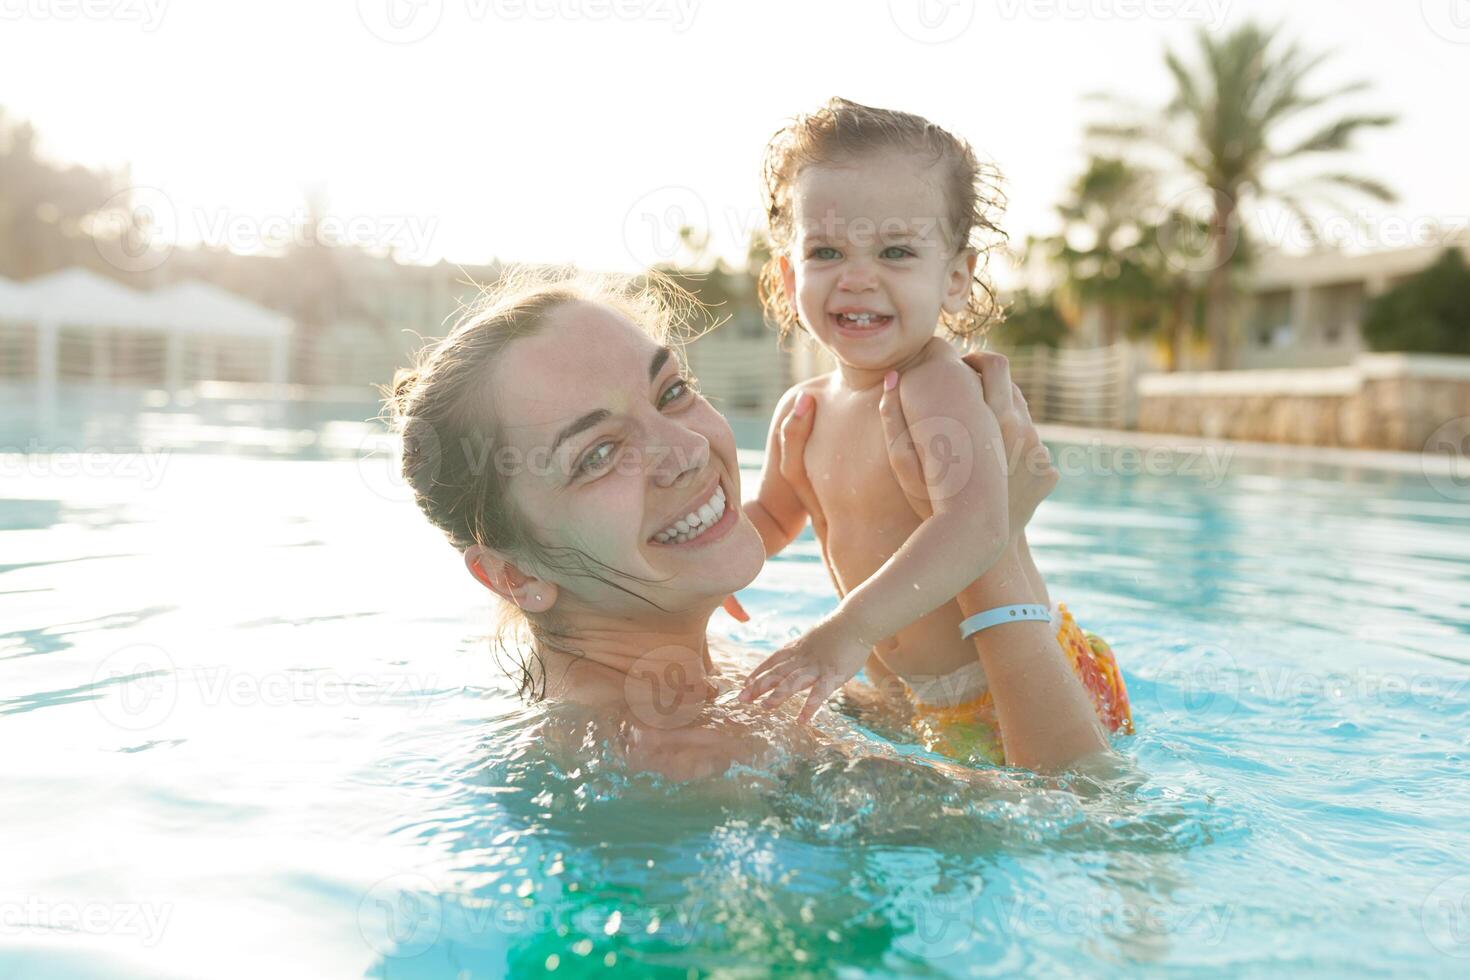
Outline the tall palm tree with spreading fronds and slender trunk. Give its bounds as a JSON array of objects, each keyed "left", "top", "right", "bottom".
[{"left": 1088, "top": 22, "right": 1397, "bottom": 369}]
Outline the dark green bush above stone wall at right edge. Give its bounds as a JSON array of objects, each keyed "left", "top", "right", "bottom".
[{"left": 1363, "top": 248, "right": 1470, "bottom": 354}]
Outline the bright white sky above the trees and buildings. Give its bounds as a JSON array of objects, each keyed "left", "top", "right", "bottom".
[{"left": 0, "top": 0, "right": 1470, "bottom": 279}]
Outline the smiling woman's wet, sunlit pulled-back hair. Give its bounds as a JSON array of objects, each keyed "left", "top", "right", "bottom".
[{"left": 384, "top": 267, "right": 709, "bottom": 698}]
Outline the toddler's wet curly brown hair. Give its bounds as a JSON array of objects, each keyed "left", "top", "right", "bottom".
[{"left": 757, "top": 98, "right": 1005, "bottom": 341}]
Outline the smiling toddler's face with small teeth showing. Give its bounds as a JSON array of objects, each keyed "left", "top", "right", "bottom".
[{"left": 782, "top": 151, "right": 972, "bottom": 370}]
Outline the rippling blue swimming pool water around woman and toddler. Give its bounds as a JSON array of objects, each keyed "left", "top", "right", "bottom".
[{"left": 0, "top": 417, "right": 1470, "bottom": 977}]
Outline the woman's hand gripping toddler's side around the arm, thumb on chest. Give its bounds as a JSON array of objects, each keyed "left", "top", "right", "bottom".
[{"left": 878, "top": 353, "right": 1060, "bottom": 539}]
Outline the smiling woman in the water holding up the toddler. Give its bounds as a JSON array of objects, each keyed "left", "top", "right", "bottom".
[{"left": 392, "top": 268, "right": 1105, "bottom": 779}]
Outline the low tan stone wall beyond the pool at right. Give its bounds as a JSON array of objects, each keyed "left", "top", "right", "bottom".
[{"left": 1138, "top": 354, "right": 1470, "bottom": 453}]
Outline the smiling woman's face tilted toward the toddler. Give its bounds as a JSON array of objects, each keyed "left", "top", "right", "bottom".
[{"left": 491, "top": 303, "right": 764, "bottom": 614}]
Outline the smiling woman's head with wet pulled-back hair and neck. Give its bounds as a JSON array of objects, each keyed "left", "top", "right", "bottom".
[{"left": 390, "top": 272, "right": 763, "bottom": 699}]
